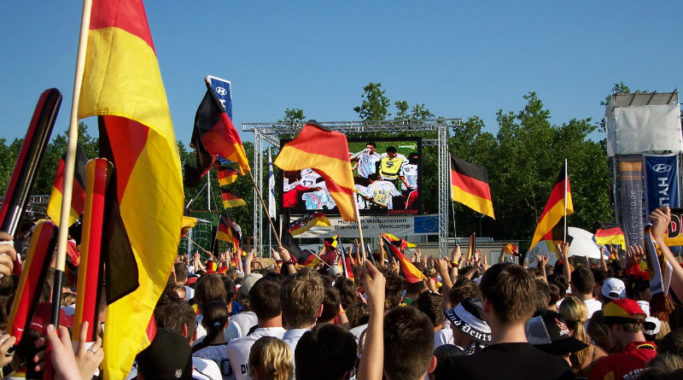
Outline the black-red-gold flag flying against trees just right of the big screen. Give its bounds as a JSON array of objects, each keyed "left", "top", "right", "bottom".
[{"left": 451, "top": 156, "right": 495, "bottom": 219}]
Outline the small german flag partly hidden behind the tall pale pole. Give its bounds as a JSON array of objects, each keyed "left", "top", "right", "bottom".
[{"left": 47, "top": 144, "right": 88, "bottom": 226}]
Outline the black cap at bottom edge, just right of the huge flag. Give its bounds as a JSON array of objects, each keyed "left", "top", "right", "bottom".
[{"left": 136, "top": 328, "right": 192, "bottom": 380}]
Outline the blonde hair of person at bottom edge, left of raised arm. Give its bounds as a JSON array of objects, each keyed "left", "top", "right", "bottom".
[{"left": 249, "top": 336, "right": 294, "bottom": 380}]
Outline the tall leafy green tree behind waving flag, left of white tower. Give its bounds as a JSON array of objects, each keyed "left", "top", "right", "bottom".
[{"left": 488, "top": 92, "right": 611, "bottom": 239}]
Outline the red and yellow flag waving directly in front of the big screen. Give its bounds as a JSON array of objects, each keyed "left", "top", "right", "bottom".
[{"left": 275, "top": 120, "right": 356, "bottom": 221}]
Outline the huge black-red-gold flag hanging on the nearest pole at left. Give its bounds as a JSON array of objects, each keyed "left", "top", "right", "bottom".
[{"left": 78, "top": 0, "right": 183, "bottom": 379}]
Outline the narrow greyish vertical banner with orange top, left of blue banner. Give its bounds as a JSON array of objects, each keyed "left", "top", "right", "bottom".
[{"left": 617, "top": 155, "right": 644, "bottom": 245}]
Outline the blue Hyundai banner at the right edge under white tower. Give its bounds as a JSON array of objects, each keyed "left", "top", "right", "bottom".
[{"left": 645, "top": 154, "right": 681, "bottom": 215}]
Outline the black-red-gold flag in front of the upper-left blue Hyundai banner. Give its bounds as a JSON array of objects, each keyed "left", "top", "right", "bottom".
[{"left": 185, "top": 78, "right": 251, "bottom": 187}]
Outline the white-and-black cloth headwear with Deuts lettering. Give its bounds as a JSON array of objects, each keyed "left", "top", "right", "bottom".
[{"left": 444, "top": 298, "right": 491, "bottom": 344}]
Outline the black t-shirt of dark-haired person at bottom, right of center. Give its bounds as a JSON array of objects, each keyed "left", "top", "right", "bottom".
[{"left": 434, "top": 343, "right": 575, "bottom": 380}]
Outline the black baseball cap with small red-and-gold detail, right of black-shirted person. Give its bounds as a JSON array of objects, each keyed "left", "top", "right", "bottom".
[{"left": 525, "top": 311, "right": 588, "bottom": 355}]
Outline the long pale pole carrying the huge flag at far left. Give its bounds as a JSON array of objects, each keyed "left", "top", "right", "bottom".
[{"left": 51, "top": 0, "right": 92, "bottom": 327}]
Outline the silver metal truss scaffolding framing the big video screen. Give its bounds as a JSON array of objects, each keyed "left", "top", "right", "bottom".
[{"left": 242, "top": 118, "right": 462, "bottom": 257}]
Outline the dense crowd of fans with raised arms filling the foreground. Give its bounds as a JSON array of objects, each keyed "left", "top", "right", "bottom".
[{"left": 0, "top": 208, "right": 683, "bottom": 380}]
